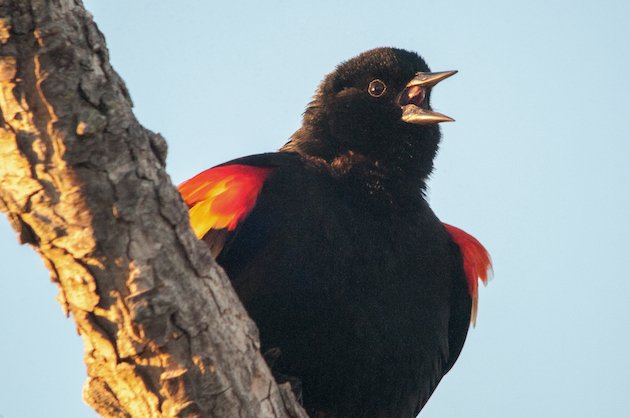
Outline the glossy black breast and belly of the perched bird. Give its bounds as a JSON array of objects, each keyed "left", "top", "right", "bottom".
[{"left": 219, "top": 161, "right": 462, "bottom": 418}]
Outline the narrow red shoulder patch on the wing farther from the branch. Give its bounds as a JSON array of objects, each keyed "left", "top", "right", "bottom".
[{"left": 444, "top": 224, "right": 492, "bottom": 325}]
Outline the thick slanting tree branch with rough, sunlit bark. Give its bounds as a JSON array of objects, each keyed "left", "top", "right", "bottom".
[{"left": 0, "top": 0, "right": 305, "bottom": 417}]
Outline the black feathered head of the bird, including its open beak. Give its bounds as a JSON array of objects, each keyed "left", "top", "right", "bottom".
[{"left": 284, "top": 48, "right": 456, "bottom": 178}]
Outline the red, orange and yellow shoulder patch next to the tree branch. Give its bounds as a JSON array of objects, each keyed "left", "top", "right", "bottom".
[{"left": 178, "top": 164, "right": 273, "bottom": 239}]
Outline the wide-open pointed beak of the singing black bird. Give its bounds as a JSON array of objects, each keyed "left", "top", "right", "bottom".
[{"left": 398, "top": 71, "right": 457, "bottom": 125}]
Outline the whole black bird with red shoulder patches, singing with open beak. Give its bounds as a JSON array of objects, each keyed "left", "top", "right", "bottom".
[{"left": 180, "top": 48, "right": 490, "bottom": 418}]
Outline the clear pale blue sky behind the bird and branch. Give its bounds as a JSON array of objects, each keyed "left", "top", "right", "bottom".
[{"left": 0, "top": 0, "right": 630, "bottom": 418}]
